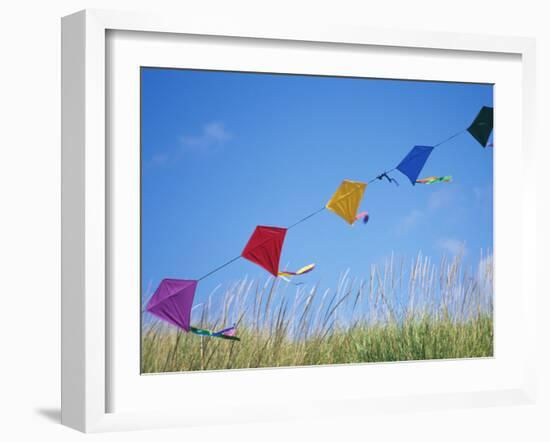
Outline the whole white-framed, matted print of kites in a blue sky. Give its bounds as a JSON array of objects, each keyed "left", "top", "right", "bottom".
[{"left": 62, "top": 11, "right": 536, "bottom": 431}]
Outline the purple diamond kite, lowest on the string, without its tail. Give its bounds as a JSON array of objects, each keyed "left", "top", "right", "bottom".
[{"left": 147, "top": 279, "right": 198, "bottom": 332}]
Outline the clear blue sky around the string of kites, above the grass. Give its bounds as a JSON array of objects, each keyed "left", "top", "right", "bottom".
[{"left": 141, "top": 68, "right": 493, "bottom": 308}]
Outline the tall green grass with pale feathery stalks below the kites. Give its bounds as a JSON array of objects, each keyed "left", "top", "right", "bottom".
[{"left": 141, "top": 255, "right": 493, "bottom": 373}]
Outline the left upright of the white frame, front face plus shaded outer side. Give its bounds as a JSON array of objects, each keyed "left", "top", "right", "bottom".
[{"left": 61, "top": 10, "right": 108, "bottom": 432}]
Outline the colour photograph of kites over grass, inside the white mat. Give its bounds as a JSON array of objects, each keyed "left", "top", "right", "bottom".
[{"left": 141, "top": 66, "right": 495, "bottom": 375}]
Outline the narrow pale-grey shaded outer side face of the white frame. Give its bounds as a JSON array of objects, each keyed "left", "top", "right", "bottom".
[{"left": 61, "top": 11, "right": 86, "bottom": 431}]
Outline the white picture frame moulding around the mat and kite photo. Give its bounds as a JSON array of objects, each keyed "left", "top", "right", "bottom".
[{"left": 62, "top": 10, "right": 536, "bottom": 432}]
